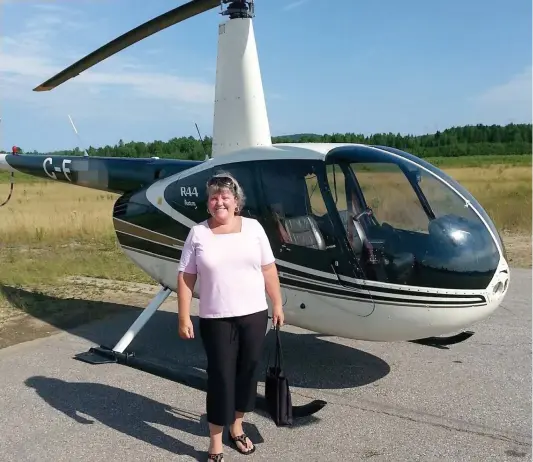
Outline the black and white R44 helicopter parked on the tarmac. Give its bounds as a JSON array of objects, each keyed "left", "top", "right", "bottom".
[{"left": 0, "top": 0, "right": 510, "bottom": 412}]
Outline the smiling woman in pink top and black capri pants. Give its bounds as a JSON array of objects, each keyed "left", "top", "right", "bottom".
[{"left": 178, "top": 173, "right": 284, "bottom": 461}]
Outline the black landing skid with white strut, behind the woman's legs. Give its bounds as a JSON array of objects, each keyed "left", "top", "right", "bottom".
[{"left": 74, "top": 287, "right": 327, "bottom": 419}]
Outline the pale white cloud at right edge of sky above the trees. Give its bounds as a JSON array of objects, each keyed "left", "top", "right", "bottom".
[{"left": 474, "top": 66, "right": 532, "bottom": 123}]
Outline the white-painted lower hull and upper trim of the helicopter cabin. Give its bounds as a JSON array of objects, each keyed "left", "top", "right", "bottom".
[{"left": 115, "top": 137, "right": 509, "bottom": 341}]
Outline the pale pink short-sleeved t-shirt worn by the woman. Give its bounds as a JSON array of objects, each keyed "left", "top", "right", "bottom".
[{"left": 178, "top": 217, "right": 275, "bottom": 318}]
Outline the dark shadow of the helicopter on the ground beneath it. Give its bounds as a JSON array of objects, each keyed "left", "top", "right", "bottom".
[{"left": 0, "top": 286, "right": 390, "bottom": 390}]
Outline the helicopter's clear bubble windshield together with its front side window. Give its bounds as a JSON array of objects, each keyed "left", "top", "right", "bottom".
[{"left": 327, "top": 146, "right": 500, "bottom": 289}]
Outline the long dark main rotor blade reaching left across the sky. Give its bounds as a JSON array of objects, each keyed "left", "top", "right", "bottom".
[{"left": 33, "top": 0, "right": 220, "bottom": 91}]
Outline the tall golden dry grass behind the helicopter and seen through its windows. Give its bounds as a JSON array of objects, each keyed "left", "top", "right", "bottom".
[{"left": 0, "top": 165, "right": 532, "bottom": 247}]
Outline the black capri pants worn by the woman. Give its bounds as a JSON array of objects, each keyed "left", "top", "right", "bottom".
[{"left": 200, "top": 310, "right": 268, "bottom": 426}]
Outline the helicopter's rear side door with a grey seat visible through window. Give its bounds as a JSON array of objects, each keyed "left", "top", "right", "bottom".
[{"left": 258, "top": 159, "right": 374, "bottom": 316}]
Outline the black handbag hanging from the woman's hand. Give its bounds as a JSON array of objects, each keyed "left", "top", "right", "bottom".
[{"left": 265, "top": 325, "right": 293, "bottom": 427}]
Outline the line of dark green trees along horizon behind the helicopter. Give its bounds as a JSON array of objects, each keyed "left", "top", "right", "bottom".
[{"left": 6, "top": 124, "right": 532, "bottom": 160}]
